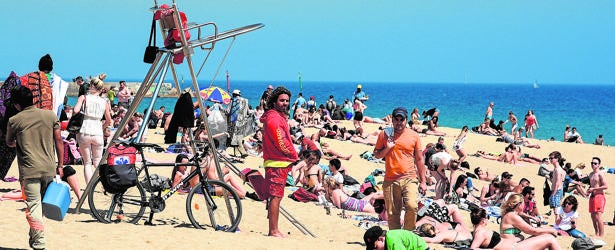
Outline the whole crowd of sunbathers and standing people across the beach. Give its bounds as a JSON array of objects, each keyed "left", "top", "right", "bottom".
[{"left": 2, "top": 57, "right": 608, "bottom": 249}]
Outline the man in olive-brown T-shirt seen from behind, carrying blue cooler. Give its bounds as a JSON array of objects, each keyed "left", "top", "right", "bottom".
[{"left": 6, "top": 86, "right": 64, "bottom": 249}]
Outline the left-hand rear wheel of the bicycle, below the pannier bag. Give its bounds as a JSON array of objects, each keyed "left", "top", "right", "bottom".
[{"left": 88, "top": 177, "right": 147, "bottom": 224}]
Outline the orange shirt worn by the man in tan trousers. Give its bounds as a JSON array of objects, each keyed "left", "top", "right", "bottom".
[{"left": 375, "top": 128, "right": 421, "bottom": 181}]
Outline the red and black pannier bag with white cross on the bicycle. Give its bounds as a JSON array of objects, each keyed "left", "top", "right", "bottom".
[{"left": 105, "top": 144, "right": 137, "bottom": 191}]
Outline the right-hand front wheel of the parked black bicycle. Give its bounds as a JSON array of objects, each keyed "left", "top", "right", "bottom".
[{"left": 186, "top": 180, "right": 241, "bottom": 232}]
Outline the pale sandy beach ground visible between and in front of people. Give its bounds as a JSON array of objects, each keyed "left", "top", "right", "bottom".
[{"left": 0, "top": 121, "right": 615, "bottom": 249}]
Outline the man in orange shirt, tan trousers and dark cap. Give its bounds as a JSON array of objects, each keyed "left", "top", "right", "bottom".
[{"left": 373, "top": 107, "right": 427, "bottom": 230}]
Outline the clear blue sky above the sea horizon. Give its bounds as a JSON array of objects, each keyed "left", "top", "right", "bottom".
[{"left": 0, "top": 0, "right": 615, "bottom": 84}]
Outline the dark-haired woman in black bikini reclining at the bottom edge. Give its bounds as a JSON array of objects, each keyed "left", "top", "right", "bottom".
[{"left": 470, "top": 207, "right": 562, "bottom": 250}]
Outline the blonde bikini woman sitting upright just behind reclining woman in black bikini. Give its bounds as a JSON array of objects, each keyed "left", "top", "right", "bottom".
[{"left": 500, "top": 194, "right": 557, "bottom": 240}]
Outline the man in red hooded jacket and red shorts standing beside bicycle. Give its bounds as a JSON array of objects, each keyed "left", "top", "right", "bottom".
[{"left": 260, "top": 87, "right": 298, "bottom": 237}]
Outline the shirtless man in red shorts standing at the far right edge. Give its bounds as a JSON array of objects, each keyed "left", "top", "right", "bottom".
[{"left": 587, "top": 157, "right": 608, "bottom": 246}]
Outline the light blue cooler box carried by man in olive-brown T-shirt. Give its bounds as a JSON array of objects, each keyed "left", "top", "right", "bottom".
[{"left": 43, "top": 178, "right": 70, "bottom": 221}]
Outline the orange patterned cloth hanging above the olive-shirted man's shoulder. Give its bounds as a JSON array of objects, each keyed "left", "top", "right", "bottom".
[{"left": 20, "top": 71, "right": 53, "bottom": 110}]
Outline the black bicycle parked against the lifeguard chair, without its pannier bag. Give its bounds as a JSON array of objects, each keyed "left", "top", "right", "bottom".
[{"left": 88, "top": 142, "right": 242, "bottom": 232}]
